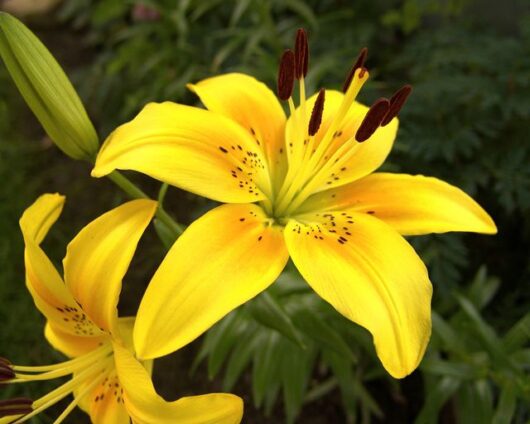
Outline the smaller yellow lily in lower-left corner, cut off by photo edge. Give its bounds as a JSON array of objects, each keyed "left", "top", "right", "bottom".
[{"left": 0, "top": 194, "right": 243, "bottom": 424}]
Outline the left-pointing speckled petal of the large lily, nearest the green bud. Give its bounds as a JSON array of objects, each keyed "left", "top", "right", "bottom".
[{"left": 92, "top": 102, "right": 270, "bottom": 203}]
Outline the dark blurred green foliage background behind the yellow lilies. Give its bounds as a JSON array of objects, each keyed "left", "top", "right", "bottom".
[{"left": 0, "top": 0, "right": 530, "bottom": 423}]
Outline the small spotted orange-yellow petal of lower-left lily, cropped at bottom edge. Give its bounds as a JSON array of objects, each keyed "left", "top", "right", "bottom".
[{"left": 88, "top": 367, "right": 131, "bottom": 424}]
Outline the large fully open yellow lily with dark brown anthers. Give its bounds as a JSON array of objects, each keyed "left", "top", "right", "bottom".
[{"left": 92, "top": 30, "right": 496, "bottom": 378}]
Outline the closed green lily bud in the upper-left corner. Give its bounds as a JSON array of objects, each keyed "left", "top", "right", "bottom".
[{"left": 0, "top": 12, "right": 99, "bottom": 159}]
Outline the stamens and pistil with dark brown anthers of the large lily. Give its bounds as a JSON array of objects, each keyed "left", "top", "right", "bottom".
[{"left": 271, "top": 30, "right": 411, "bottom": 222}]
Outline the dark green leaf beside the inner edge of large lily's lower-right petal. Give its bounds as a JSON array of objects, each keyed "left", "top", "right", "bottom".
[{"left": 293, "top": 309, "right": 357, "bottom": 362}]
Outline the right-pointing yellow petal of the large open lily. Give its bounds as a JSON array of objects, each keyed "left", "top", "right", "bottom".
[{"left": 303, "top": 173, "right": 497, "bottom": 235}]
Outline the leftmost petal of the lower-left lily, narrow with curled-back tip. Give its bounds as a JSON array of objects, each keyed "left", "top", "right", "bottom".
[{"left": 20, "top": 194, "right": 101, "bottom": 336}]
